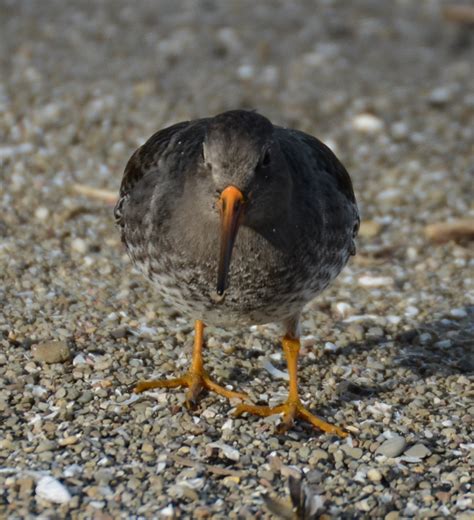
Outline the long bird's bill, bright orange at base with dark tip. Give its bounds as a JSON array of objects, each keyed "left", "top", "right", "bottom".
[{"left": 217, "top": 186, "right": 244, "bottom": 296}]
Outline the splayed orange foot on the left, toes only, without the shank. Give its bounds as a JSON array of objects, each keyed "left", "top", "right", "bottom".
[{"left": 133, "top": 371, "right": 247, "bottom": 409}]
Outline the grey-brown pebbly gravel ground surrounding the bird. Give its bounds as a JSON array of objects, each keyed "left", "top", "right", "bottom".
[{"left": 0, "top": 0, "right": 474, "bottom": 520}]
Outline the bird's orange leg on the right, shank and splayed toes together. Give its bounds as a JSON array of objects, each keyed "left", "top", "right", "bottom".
[{"left": 235, "top": 335, "right": 347, "bottom": 437}]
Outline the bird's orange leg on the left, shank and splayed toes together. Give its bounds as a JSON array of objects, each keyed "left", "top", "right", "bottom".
[{"left": 133, "top": 320, "right": 247, "bottom": 408}]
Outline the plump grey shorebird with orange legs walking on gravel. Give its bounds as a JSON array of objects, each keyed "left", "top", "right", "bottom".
[{"left": 114, "top": 109, "right": 360, "bottom": 437}]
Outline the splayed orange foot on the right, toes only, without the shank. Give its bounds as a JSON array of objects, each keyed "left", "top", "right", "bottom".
[{"left": 235, "top": 399, "right": 348, "bottom": 437}]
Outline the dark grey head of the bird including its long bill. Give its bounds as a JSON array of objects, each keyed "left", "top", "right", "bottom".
[{"left": 202, "top": 110, "right": 291, "bottom": 296}]
